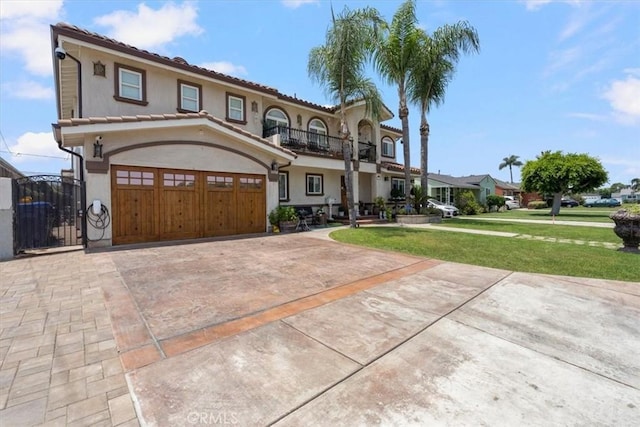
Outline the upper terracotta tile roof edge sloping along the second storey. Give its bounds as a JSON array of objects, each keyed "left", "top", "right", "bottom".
[{"left": 51, "top": 22, "right": 338, "bottom": 113}]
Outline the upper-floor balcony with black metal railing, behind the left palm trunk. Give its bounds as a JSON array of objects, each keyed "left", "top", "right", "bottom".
[{"left": 262, "top": 126, "right": 376, "bottom": 163}]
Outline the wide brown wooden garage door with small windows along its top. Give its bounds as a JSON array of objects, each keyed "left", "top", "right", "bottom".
[{"left": 111, "top": 166, "right": 266, "bottom": 245}]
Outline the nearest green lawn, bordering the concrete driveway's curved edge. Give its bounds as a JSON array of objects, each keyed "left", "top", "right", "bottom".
[{"left": 331, "top": 227, "right": 640, "bottom": 282}]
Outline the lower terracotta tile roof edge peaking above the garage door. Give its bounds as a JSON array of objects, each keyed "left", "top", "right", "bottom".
[{"left": 58, "top": 110, "right": 298, "bottom": 158}]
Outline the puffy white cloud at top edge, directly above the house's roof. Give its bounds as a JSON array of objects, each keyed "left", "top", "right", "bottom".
[{"left": 94, "top": 2, "right": 203, "bottom": 49}]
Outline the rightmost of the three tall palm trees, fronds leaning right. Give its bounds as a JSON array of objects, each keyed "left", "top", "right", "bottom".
[{"left": 408, "top": 21, "right": 480, "bottom": 189}]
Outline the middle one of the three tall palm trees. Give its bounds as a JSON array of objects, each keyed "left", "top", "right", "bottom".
[{"left": 374, "top": 0, "right": 423, "bottom": 201}]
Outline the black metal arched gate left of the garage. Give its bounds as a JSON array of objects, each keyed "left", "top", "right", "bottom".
[{"left": 13, "top": 175, "right": 86, "bottom": 255}]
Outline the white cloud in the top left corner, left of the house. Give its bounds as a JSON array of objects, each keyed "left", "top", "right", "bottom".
[{"left": 0, "top": 0, "right": 62, "bottom": 76}]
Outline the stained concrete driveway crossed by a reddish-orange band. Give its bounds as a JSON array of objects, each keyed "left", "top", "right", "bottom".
[{"left": 0, "top": 231, "right": 640, "bottom": 426}]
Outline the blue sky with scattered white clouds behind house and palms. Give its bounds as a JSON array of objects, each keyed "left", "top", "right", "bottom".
[{"left": 0, "top": 0, "right": 640, "bottom": 184}]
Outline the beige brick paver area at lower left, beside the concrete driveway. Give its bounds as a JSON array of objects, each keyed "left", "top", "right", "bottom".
[{"left": 0, "top": 252, "right": 138, "bottom": 426}]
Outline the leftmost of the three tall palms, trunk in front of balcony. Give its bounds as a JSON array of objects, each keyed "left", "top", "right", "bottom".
[{"left": 307, "top": 7, "right": 385, "bottom": 228}]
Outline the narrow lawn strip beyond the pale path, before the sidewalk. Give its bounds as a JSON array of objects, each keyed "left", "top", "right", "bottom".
[{"left": 434, "top": 221, "right": 616, "bottom": 244}]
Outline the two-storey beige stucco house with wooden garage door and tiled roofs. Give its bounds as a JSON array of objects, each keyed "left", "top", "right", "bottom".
[{"left": 51, "top": 23, "right": 419, "bottom": 246}]
